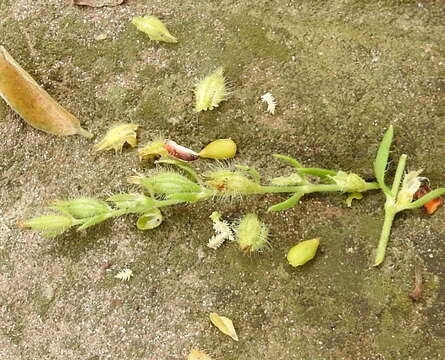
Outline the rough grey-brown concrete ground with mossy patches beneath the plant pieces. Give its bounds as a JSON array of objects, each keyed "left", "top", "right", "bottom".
[{"left": 0, "top": 0, "right": 445, "bottom": 360}]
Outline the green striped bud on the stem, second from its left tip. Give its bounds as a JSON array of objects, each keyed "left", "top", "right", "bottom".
[{"left": 51, "top": 198, "right": 111, "bottom": 219}]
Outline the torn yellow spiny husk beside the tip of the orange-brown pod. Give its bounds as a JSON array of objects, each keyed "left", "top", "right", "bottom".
[{"left": 94, "top": 124, "right": 139, "bottom": 152}]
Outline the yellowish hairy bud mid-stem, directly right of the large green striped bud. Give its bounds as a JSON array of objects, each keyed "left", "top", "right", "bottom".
[{"left": 204, "top": 170, "right": 261, "bottom": 195}]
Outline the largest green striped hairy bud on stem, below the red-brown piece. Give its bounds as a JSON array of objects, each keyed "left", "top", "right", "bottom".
[{"left": 129, "top": 172, "right": 202, "bottom": 195}]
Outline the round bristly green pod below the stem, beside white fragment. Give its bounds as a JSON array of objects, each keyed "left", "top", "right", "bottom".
[{"left": 236, "top": 214, "right": 269, "bottom": 253}]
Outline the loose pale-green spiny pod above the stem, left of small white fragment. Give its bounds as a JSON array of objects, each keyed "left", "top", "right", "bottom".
[{"left": 195, "top": 67, "right": 228, "bottom": 112}]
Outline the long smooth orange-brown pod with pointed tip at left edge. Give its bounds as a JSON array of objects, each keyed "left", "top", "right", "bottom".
[{"left": 0, "top": 46, "right": 93, "bottom": 138}]
